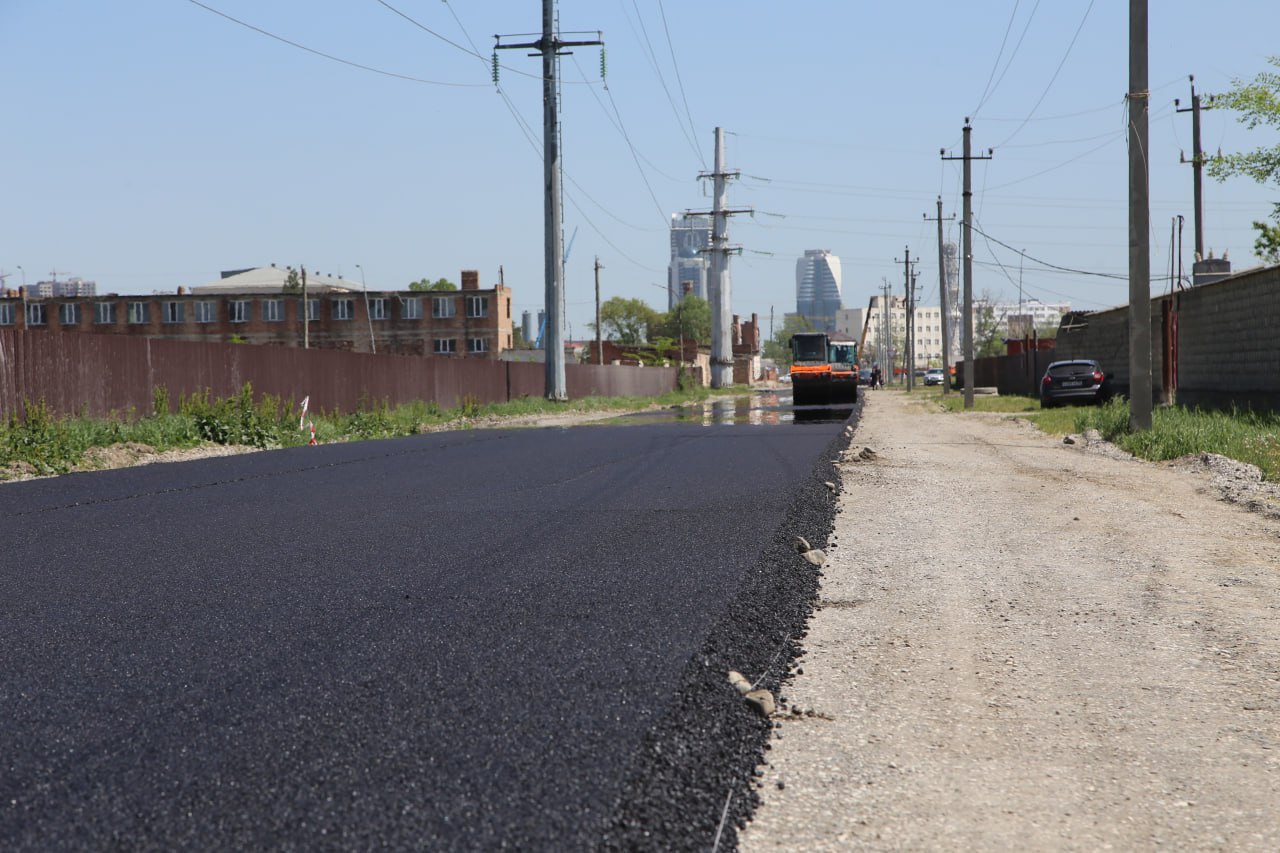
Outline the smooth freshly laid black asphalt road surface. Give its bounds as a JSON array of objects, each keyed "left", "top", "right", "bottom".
[{"left": 0, "top": 409, "right": 841, "bottom": 850}]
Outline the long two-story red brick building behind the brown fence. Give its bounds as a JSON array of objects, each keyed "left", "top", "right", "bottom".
[{"left": 0, "top": 266, "right": 513, "bottom": 357}]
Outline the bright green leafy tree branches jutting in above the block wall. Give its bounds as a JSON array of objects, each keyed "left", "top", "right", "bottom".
[{"left": 1208, "top": 56, "right": 1280, "bottom": 264}]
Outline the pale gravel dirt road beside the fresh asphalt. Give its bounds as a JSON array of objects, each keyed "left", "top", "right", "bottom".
[{"left": 740, "top": 392, "right": 1280, "bottom": 853}]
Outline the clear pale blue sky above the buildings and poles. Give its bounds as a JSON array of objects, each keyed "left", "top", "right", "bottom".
[{"left": 0, "top": 0, "right": 1280, "bottom": 338}]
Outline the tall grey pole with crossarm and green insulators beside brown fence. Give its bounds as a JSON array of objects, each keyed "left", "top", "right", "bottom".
[{"left": 494, "top": 0, "right": 604, "bottom": 401}]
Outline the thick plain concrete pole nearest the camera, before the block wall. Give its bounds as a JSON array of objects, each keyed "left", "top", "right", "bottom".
[{"left": 1128, "top": 0, "right": 1151, "bottom": 432}]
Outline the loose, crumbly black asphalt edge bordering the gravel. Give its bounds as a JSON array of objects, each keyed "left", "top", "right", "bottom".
[{"left": 598, "top": 401, "right": 863, "bottom": 852}]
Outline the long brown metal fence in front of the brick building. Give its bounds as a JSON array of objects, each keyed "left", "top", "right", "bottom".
[{"left": 0, "top": 329, "right": 677, "bottom": 418}]
